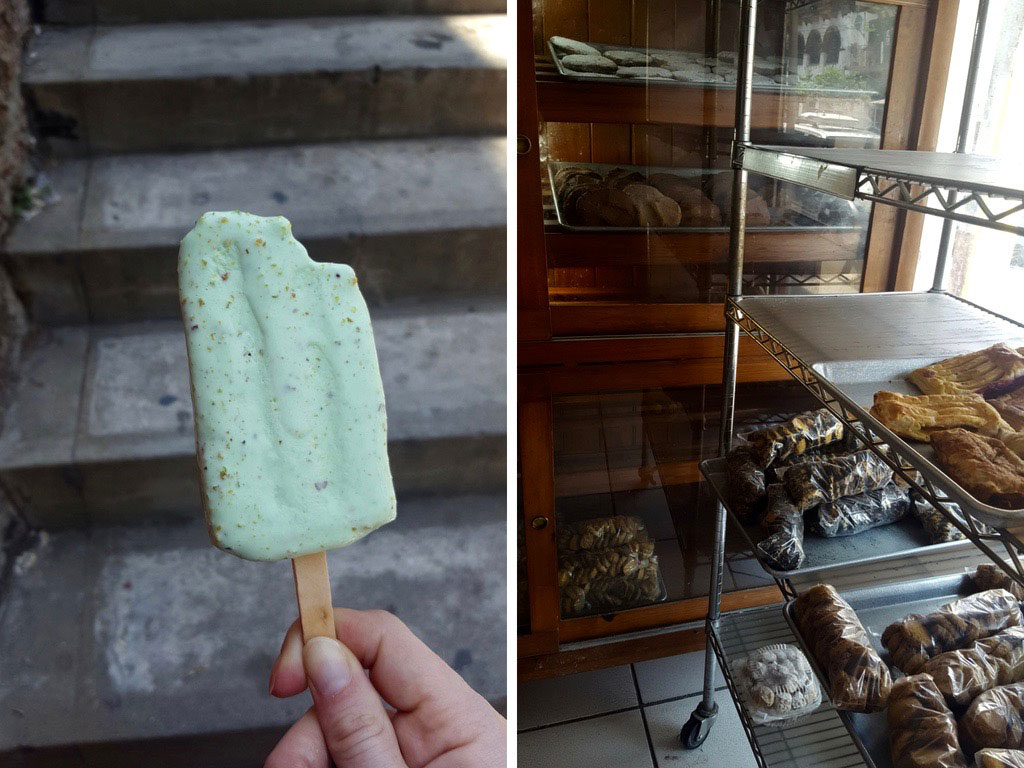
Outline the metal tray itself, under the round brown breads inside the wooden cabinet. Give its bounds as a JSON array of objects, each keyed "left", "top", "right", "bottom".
[{"left": 548, "top": 160, "right": 867, "bottom": 234}]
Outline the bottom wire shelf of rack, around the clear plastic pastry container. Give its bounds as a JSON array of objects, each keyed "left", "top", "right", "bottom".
[{"left": 708, "top": 604, "right": 870, "bottom": 768}]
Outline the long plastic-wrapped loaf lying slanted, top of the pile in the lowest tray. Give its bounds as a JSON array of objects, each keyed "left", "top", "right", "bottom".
[{"left": 882, "top": 590, "right": 1024, "bottom": 675}]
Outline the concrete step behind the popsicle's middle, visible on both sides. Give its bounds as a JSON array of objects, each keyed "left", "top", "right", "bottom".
[{"left": 0, "top": 302, "right": 506, "bottom": 528}]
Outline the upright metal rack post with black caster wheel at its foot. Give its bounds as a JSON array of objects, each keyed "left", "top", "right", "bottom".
[{"left": 679, "top": 0, "right": 758, "bottom": 750}]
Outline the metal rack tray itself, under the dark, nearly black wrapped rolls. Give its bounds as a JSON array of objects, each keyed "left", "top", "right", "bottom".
[{"left": 699, "top": 459, "right": 973, "bottom": 580}]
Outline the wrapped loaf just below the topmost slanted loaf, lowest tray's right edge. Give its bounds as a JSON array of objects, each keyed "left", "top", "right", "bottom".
[{"left": 924, "top": 627, "right": 1024, "bottom": 707}]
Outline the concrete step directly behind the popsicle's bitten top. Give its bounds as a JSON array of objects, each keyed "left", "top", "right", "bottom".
[{"left": 4, "top": 137, "right": 506, "bottom": 325}]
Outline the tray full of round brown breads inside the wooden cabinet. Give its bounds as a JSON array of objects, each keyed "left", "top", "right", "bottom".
[{"left": 548, "top": 161, "right": 868, "bottom": 233}]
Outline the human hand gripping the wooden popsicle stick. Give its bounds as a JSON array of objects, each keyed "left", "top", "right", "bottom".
[{"left": 265, "top": 608, "right": 506, "bottom": 768}]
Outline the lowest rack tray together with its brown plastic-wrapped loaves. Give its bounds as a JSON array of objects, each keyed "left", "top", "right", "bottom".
[{"left": 783, "top": 565, "right": 1024, "bottom": 768}]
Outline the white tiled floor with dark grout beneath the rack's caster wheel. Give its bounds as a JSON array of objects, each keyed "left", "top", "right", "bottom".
[{"left": 518, "top": 651, "right": 756, "bottom": 768}]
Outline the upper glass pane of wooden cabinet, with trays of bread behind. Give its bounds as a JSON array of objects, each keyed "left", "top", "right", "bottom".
[{"left": 538, "top": 0, "right": 898, "bottom": 333}]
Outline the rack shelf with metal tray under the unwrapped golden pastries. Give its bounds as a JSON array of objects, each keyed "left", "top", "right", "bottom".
[{"left": 726, "top": 292, "right": 1024, "bottom": 584}]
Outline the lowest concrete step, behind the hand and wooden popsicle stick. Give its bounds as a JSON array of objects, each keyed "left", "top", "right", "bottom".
[{"left": 0, "top": 492, "right": 506, "bottom": 768}]
